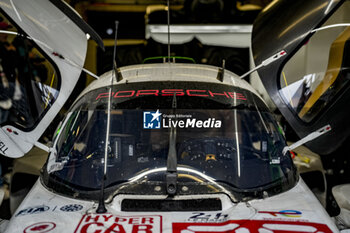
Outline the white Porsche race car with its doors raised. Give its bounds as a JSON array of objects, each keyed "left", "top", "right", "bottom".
[{"left": 0, "top": 0, "right": 346, "bottom": 233}]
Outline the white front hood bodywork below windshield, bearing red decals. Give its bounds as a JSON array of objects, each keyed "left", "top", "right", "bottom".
[{"left": 1, "top": 180, "right": 338, "bottom": 233}]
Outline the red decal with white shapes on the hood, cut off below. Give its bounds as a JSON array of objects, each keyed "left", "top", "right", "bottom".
[{"left": 173, "top": 220, "right": 332, "bottom": 233}]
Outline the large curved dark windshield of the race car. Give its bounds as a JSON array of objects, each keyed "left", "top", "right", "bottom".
[{"left": 42, "top": 81, "right": 295, "bottom": 200}]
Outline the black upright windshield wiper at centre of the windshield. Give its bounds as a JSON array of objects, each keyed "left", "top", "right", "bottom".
[{"left": 166, "top": 93, "right": 177, "bottom": 196}]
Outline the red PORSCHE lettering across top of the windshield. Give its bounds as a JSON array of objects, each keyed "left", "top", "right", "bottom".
[{"left": 96, "top": 89, "right": 247, "bottom": 100}]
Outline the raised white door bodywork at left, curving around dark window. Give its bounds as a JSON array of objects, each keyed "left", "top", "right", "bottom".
[{"left": 0, "top": 0, "right": 87, "bottom": 158}]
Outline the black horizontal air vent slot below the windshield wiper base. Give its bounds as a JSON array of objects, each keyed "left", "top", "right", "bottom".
[{"left": 122, "top": 198, "right": 222, "bottom": 212}]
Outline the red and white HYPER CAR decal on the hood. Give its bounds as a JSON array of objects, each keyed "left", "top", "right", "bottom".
[{"left": 74, "top": 214, "right": 162, "bottom": 233}]
